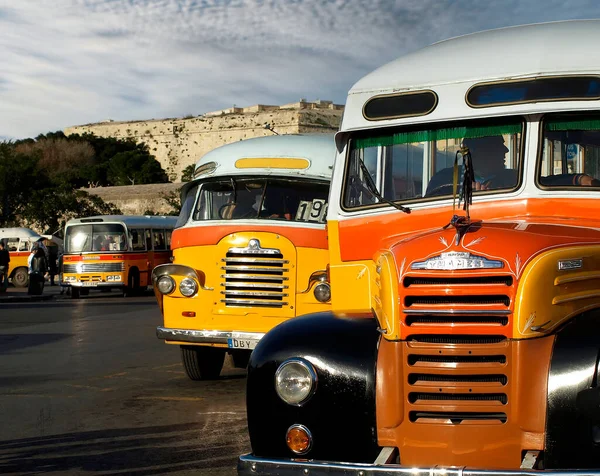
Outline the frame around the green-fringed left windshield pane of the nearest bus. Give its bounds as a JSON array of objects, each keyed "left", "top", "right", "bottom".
[{"left": 339, "top": 114, "right": 528, "bottom": 213}]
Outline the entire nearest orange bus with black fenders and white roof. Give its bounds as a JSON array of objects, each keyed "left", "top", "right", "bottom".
[{"left": 238, "top": 20, "right": 600, "bottom": 476}]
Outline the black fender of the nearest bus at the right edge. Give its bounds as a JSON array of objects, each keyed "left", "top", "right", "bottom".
[{"left": 544, "top": 309, "right": 600, "bottom": 469}]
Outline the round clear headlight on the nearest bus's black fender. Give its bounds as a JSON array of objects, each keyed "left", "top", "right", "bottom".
[{"left": 275, "top": 359, "right": 317, "bottom": 406}]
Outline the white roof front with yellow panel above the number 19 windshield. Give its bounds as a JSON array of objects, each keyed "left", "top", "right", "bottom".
[{"left": 194, "top": 134, "right": 335, "bottom": 180}]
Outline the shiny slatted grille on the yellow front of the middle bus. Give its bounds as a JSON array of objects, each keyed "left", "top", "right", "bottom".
[{"left": 221, "top": 248, "right": 289, "bottom": 308}]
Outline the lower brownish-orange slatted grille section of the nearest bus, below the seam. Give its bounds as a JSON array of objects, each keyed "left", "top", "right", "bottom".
[{"left": 404, "top": 335, "right": 512, "bottom": 425}]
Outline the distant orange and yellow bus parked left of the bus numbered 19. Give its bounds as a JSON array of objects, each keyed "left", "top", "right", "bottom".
[{"left": 61, "top": 215, "right": 177, "bottom": 299}]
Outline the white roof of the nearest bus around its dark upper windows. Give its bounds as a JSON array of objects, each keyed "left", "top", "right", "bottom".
[{"left": 341, "top": 20, "right": 600, "bottom": 130}]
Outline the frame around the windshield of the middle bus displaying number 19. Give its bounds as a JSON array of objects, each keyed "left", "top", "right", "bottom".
[{"left": 186, "top": 174, "right": 331, "bottom": 226}]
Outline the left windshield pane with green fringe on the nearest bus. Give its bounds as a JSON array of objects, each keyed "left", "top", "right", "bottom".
[{"left": 344, "top": 119, "right": 523, "bottom": 208}]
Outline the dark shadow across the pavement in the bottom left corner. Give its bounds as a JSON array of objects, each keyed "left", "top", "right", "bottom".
[{"left": 0, "top": 422, "right": 247, "bottom": 476}]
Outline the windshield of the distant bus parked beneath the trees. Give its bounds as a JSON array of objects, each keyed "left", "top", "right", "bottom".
[{"left": 65, "top": 223, "right": 127, "bottom": 253}]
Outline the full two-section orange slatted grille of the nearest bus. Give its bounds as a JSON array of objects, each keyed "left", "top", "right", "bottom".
[{"left": 400, "top": 273, "right": 516, "bottom": 425}]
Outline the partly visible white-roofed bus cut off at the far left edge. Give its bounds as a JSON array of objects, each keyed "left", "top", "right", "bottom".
[{"left": 0, "top": 228, "right": 44, "bottom": 288}]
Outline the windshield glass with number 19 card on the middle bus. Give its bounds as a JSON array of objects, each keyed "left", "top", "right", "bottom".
[{"left": 193, "top": 177, "right": 329, "bottom": 223}]
